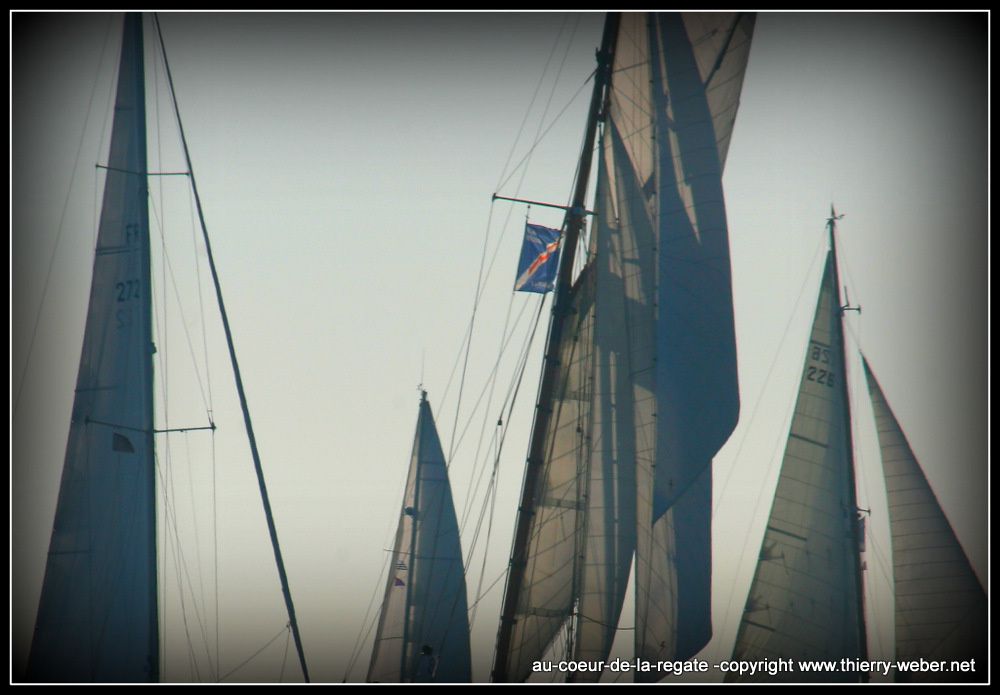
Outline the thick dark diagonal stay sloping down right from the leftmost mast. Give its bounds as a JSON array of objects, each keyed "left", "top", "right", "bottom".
[{"left": 153, "top": 14, "right": 309, "bottom": 683}]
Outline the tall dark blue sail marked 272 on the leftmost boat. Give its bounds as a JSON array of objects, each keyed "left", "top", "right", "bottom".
[{"left": 28, "top": 14, "right": 159, "bottom": 682}]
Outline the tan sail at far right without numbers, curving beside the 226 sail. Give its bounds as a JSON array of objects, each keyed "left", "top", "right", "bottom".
[{"left": 864, "top": 359, "right": 987, "bottom": 681}]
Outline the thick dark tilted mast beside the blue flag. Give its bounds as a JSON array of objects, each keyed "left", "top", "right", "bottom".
[{"left": 493, "top": 13, "right": 619, "bottom": 682}]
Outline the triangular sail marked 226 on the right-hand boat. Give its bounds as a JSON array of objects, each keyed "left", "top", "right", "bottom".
[{"left": 733, "top": 251, "right": 865, "bottom": 682}]
